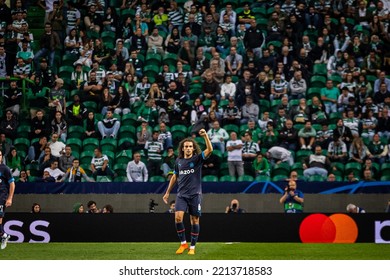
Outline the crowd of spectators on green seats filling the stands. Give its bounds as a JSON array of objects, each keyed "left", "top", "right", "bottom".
[{"left": 0, "top": 0, "right": 390, "bottom": 182}]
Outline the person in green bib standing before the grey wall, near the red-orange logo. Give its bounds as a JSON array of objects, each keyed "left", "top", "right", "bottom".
[{"left": 279, "top": 180, "right": 304, "bottom": 213}]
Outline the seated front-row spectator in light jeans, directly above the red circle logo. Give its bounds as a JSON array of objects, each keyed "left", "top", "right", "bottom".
[{"left": 303, "top": 146, "right": 330, "bottom": 178}]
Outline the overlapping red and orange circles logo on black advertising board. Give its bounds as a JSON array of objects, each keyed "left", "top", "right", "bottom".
[{"left": 299, "top": 214, "right": 359, "bottom": 243}]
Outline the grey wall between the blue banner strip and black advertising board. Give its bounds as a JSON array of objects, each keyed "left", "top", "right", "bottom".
[{"left": 7, "top": 194, "right": 390, "bottom": 213}]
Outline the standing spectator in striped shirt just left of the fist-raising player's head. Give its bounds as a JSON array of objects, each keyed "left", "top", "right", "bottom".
[{"left": 144, "top": 131, "right": 164, "bottom": 177}]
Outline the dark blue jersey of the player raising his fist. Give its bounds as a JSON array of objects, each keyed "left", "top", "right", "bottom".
[{"left": 175, "top": 152, "right": 205, "bottom": 197}]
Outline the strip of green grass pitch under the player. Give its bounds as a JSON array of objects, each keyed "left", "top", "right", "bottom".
[{"left": 0, "top": 242, "right": 390, "bottom": 260}]
